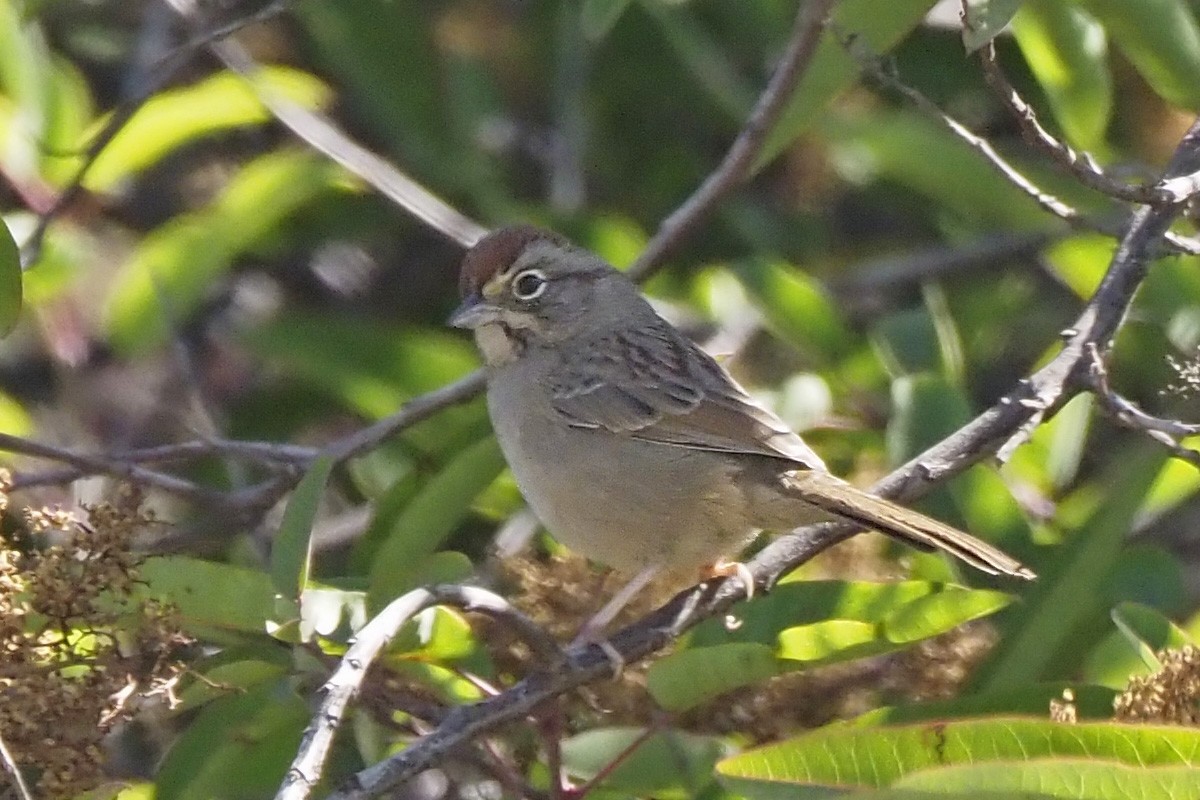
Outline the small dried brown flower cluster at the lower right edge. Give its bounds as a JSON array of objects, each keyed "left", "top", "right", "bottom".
[{"left": 1114, "top": 644, "right": 1200, "bottom": 726}]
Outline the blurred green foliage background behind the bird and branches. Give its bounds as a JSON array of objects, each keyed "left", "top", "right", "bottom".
[{"left": 0, "top": 0, "right": 1200, "bottom": 798}]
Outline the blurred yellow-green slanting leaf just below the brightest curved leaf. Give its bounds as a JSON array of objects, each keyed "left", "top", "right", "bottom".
[{"left": 107, "top": 150, "right": 342, "bottom": 354}]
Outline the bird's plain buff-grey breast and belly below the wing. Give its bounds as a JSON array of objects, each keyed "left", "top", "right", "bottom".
[{"left": 487, "top": 368, "right": 755, "bottom": 572}]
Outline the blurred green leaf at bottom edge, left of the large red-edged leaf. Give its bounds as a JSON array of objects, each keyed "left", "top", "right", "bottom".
[{"left": 563, "top": 728, "right": 730, "bottom": 798}]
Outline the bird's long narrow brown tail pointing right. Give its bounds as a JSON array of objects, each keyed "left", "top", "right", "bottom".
[{"left": 785, "top": 470, "right": 1037, "bottom": 581}]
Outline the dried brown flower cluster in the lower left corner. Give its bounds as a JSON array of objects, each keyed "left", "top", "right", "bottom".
[{"left": 0, "top": 471, "right": 184, "bottom": 798}]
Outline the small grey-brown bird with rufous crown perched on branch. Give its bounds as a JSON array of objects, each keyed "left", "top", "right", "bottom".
[{"left": 449, "top": 224, "right": 1036, "bottom": 625}]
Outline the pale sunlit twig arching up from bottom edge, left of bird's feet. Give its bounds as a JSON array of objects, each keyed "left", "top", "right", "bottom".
[{"left": 275, "top": 587, "right": 562, "bottom": 800}]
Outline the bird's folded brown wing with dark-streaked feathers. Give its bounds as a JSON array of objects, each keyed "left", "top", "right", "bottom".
[{"left": 550, "top": 319, "right": 824, "bottom": 470}]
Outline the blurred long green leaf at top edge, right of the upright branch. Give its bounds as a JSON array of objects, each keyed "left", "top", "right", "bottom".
[{"left": 755, "top": 0, "right": 936, "bottom": 170}]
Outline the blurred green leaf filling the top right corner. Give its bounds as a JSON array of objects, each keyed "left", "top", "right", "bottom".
[{"left": 1081, "top": 0, "right": 1200, "bottom": 110}]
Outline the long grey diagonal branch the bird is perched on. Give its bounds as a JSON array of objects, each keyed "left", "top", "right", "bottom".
[{"left": 331, "top": 112, "right": 1200, "bottom": 800}]
